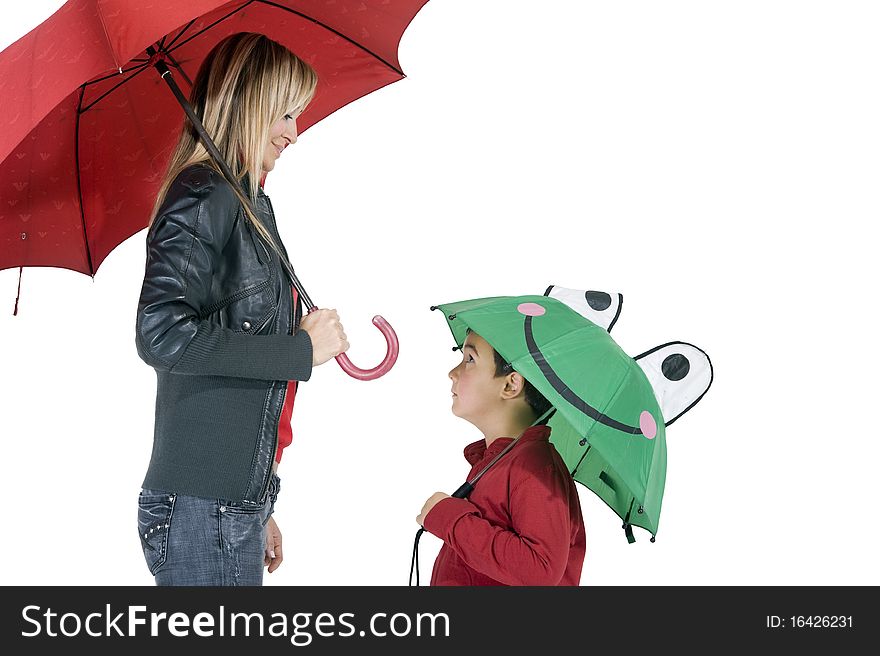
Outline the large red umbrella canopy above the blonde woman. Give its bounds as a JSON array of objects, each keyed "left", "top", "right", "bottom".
[{"left": 0, "top": 0, "right": 427, "bottom": 274}]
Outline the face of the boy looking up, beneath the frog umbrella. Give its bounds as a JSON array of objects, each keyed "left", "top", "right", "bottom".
[{"left": 449, "top": 333, "right": 506, "bottom": 423}]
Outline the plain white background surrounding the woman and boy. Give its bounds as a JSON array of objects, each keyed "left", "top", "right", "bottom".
[{"left": 0, "top": 0, "right": 880, "bottom": 585}]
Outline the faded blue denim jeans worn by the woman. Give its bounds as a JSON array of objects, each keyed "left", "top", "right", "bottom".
[{"left": 138, "top": 474, "right": 281, "bottom": 586}]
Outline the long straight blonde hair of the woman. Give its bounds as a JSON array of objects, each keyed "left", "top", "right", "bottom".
[{"left": 147, "top": 32, "right": 318, "bottom": 259}]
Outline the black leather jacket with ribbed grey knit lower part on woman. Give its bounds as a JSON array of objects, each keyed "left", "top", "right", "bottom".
[{"left": 136, "top": 165, "right": 312, "bottom": 505}]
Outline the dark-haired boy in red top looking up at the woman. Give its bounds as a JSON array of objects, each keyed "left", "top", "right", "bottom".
[{"left": 416, "top": 331, "right": 585, "bottom": 585}]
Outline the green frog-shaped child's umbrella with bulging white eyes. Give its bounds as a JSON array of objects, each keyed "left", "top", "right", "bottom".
[{"left": 431, "top": 286, "right": 712, "bottom": 542}]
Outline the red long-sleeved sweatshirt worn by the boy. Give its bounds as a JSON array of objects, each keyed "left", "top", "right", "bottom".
[{"left": 424, "top": 426, "right": 586, "bottom": 585}]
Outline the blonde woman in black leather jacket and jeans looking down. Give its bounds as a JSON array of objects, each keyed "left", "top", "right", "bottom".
[{"left": 136, "top": 33, "right": 348, "bottom": 585}]
